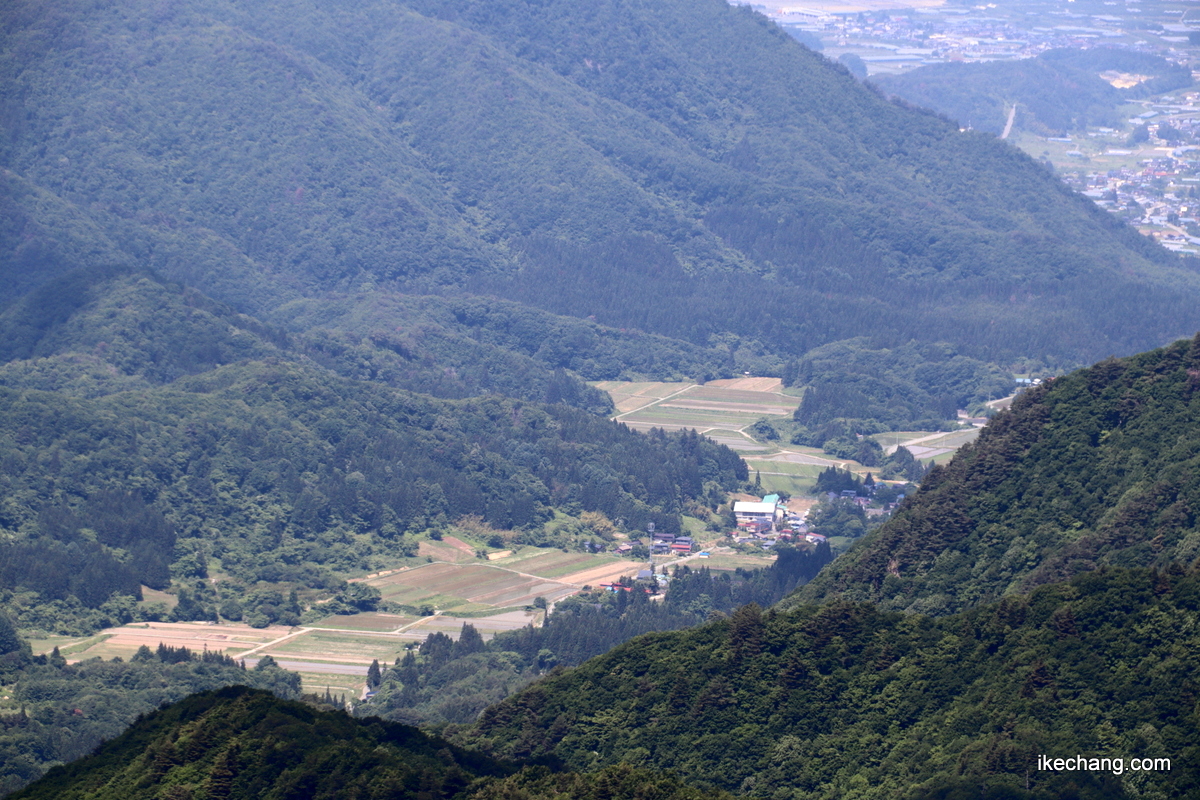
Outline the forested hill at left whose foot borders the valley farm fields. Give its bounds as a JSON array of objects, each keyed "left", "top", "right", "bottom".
[{"left": 0, "top": 350, "right": 746, "bottom": 633}]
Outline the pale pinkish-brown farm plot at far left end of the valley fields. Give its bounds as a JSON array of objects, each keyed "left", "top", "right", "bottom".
[{"left": 59, "top": 622, "right": 290, "bottom": 661}]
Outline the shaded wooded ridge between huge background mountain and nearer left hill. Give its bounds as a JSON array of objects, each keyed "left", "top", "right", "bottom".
[{"left": 0, "top": 267, "right": 715, "bottom": 414}]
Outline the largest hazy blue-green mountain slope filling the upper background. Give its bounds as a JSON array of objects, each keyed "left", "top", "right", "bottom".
[{"left": 9, "top": 0, "right": 1200, "bottom": 362}]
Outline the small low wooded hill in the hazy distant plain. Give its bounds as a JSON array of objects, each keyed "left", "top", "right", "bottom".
[{"left": 871, "top": 47, "right": 1192, "bottom": 136}]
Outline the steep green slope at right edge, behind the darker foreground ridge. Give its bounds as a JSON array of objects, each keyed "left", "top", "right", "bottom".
[{"left": 784, "top": 336, "right": 1200, "bottom": 614}]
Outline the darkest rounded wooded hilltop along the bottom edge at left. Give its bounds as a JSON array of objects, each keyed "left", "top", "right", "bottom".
[{"left": 11, "top": 687, "right": 728, "bottom": 800}]
